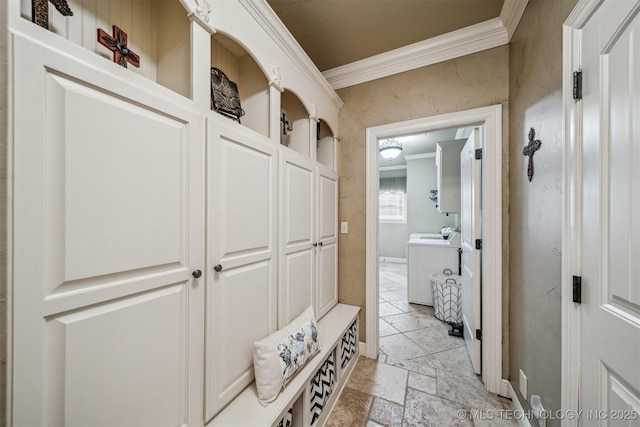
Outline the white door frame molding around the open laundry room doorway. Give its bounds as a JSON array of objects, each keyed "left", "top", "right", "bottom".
[{"left": 365, "top": 104, "right": 508, "bottom": 396}]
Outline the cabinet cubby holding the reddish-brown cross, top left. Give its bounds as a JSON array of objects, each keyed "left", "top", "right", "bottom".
[{"left": 20, "top": 0, "right": 191, "bottom": 98}]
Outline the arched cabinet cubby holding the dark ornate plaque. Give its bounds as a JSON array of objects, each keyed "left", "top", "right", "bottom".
[{"left": 211, "top": 34, "right": 269, "bottom": 137}]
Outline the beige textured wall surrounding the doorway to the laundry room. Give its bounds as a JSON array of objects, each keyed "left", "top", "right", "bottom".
[{"left": 338, "top": 46, "right": 509, "bottom": 374}]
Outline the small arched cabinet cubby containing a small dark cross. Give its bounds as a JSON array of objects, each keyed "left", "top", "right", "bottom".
[{"left": 280, "top": 90, "right": 311, "bottom": 158}]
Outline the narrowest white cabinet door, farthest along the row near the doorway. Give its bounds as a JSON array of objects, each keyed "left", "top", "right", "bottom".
[{"left": 315, "top": 166, "right": 338, "bottom": 318}]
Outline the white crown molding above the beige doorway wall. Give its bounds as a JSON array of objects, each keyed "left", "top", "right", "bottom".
[{"left": 322, "top": 0, "right": 529, "bottom": 90}]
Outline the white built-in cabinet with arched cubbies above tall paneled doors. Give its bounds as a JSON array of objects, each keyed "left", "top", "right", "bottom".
[{"left": 8, "top": 0, "right": 341, "bottom": 426}]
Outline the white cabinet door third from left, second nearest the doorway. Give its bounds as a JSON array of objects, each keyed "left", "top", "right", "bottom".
[{"left": 278, "top": 152, "right": 317, "bottom": 327}]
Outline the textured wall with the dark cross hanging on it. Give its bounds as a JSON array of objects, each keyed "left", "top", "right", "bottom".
[{"left": 509, "top": 0, "right": 576, "bottom": 426}]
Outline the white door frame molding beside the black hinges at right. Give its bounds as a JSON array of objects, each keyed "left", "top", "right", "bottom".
[{"left": 561, "top": 0, "right": 604, "bottom": 426}]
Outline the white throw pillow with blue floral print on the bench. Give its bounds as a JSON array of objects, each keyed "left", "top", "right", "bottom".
[{"left": 253, "top": 306, "right": 320, "bottom": 406}]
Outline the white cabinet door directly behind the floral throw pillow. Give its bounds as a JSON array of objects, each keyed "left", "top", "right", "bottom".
[{"left": 206, "top": 117, "right": 278, "bottom": 421}]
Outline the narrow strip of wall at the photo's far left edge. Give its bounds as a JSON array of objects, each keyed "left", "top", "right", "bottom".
[{"left": 0, "top": 1, "right": 8, "bottom": 426}]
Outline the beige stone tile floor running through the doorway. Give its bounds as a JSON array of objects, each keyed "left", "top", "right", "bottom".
[{"left": 325, "top": 262, "right": 517, "bottom": 427}]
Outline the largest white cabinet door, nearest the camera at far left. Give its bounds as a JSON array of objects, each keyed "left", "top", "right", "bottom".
[{"left": 11, "top": 34, "right": 204, "bottom": 426}]
